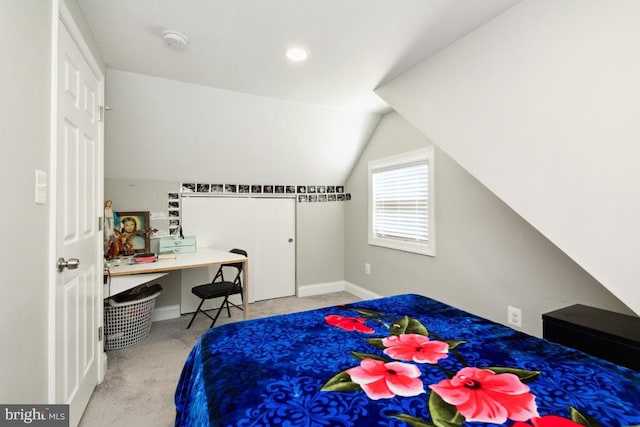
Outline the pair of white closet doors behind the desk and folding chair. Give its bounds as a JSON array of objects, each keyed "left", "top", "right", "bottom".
[{"left": 181, "top": 197, "right": 295, "bottom": 313}]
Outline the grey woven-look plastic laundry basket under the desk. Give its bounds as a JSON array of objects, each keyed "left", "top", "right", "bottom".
[{"left": 104, "top": 291, "right": 161, "bottom": 350}]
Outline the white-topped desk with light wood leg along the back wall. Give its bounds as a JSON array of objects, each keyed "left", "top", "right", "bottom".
[{"left": 109, "top": 247, "right": 249, "bottom": 320}]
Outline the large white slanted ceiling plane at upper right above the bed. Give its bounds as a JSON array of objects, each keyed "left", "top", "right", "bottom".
[{"left": 377, "top": 0, "right": 640, "bottom": 313}]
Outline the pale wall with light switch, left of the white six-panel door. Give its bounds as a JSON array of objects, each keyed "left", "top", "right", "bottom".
[{"left": 0, "top": 0, "right": 53, "bottom": 403}]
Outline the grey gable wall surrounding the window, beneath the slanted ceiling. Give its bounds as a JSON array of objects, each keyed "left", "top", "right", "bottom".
[{"left": 345, "top": 113, "right": 631, "bottom": 336}]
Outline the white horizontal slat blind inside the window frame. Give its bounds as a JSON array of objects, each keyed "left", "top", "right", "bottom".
[{"left": 372, "top": 161, "right": 429, "bottom": 243}]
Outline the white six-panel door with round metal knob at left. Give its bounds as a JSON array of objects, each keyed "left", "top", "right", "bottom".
[{"left": 54, "top": 21, "right": 103, "bottom": 425}]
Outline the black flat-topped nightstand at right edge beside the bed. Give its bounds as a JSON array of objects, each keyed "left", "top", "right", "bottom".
[{"left": 542, "top": 304, "right": 640, "bottom": 371}]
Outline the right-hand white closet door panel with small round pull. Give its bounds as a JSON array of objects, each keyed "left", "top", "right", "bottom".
[{"left": 254, "top": 199, "right": 296, "bottom": 301}]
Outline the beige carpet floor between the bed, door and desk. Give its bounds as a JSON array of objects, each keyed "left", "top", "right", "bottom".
[{"left": 80, "top": 292, "right": 360, "bottom": 427}]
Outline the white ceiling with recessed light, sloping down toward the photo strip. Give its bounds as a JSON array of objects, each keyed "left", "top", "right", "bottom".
[{"left": 79, "top": 0, "right": 518, "bottom": 183}]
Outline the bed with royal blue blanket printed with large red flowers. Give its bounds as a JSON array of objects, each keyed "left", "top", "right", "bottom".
[{"left": 175, "top": 294, "right": 640, "bottom": 427}]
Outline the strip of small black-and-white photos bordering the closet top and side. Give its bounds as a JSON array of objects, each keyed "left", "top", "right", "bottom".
[{"left": 168, "top": 183, "right": 351, "bottom": 236}]
